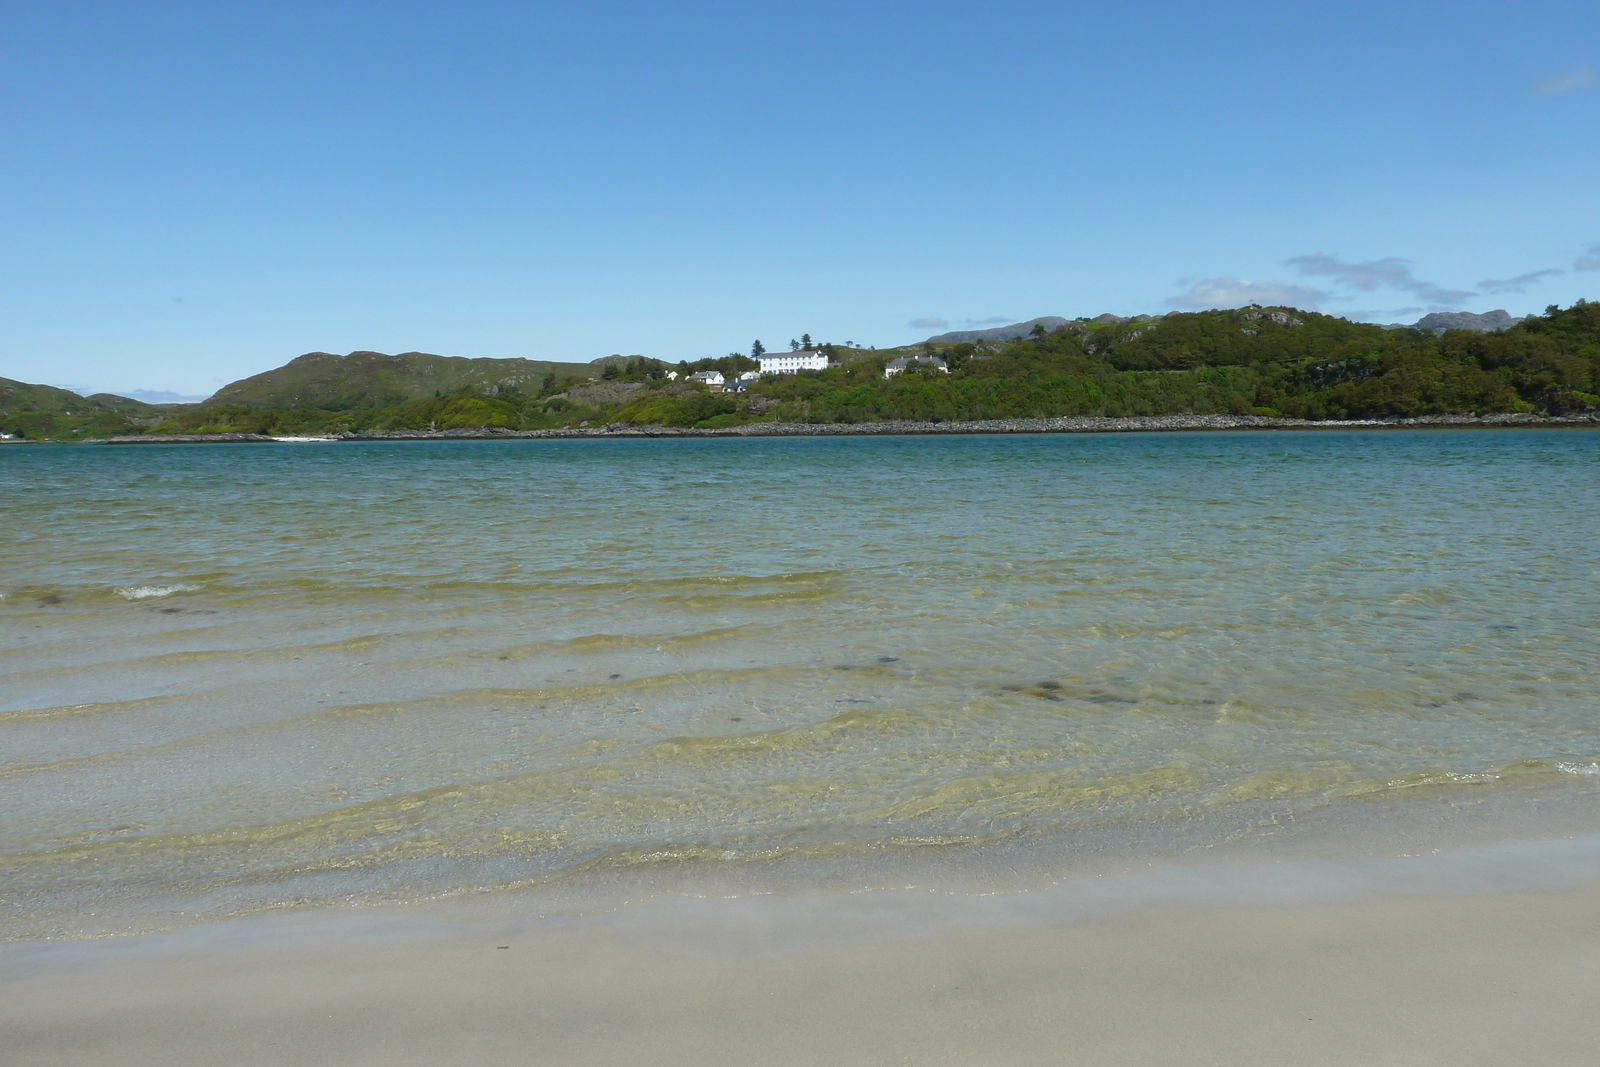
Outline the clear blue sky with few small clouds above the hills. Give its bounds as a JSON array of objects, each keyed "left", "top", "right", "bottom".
[{"left": 0, "top": 0, "right": 1600, "bottom": 394}]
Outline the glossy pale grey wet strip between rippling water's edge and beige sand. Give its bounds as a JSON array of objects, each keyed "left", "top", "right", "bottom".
[{"left": 12, "top": 835, "right": 1600, "bottom": 981}]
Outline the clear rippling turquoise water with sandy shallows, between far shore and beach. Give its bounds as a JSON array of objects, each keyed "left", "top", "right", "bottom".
[{"left": 0, "top": 430, "right": 1600, "bottom": 937}]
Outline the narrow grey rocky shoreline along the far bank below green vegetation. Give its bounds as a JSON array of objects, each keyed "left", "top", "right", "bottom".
[{"left": 86, "top": 413, "right": 1600, "bottom": 445}]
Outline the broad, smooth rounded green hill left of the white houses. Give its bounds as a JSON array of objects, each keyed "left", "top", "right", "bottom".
[{"left": 205, "top": 352, "right": 600, "bottom": 411}]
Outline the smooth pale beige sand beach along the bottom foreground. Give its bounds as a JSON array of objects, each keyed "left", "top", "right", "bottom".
[{"left": 0, "top": 883, "right": 1600, "bottom": 1065}]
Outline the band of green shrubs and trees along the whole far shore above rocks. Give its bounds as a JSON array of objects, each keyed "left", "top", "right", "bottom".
[{"left": 12, "top": 301, "right": 1600, "bottom": 438}]
